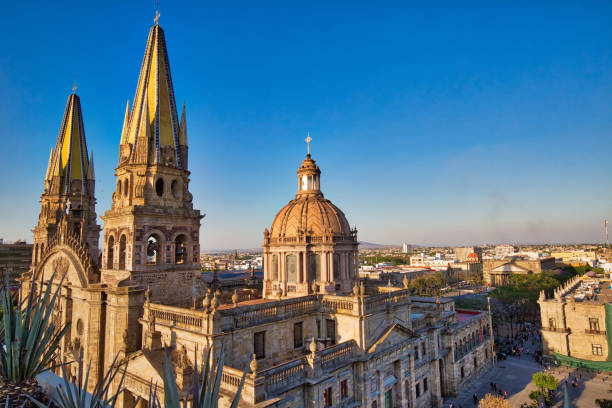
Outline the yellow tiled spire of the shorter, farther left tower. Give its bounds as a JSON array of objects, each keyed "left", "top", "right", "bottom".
[{"left": 47, "top": 93, "right": 89, "bottom": 194}]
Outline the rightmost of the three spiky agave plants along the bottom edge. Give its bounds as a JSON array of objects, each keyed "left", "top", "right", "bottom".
[{"left": 149, "top": 348, "right": 247, "bottom": 408}]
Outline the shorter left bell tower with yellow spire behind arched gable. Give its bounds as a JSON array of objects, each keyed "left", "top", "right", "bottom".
[{"left": 32, "top": 86, "right": 100, "bottom": 267}]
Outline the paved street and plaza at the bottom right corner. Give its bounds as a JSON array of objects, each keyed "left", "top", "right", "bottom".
[{"left": 443, "top": 356, "right": 612, "bottom": 408}]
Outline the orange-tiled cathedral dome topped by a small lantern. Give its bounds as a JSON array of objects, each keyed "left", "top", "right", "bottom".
[{"left": 270, "top": 154, "right": 352, "bottom": 239}]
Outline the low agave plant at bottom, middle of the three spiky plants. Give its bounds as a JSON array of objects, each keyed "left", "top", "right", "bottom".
[{"left": 30, "top": 354, "right": 140, "bottom": 408}]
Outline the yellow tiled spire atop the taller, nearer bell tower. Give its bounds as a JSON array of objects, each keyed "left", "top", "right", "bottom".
[{"left": 121, "top": 24, "right": 183, "bottom": 168}]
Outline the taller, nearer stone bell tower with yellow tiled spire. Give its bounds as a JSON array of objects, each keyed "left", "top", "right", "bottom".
[{"left": 102, "top": 21, "right": 203, "bottom": 302}]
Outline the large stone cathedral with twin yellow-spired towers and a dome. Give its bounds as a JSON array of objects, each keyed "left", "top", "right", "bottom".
[{"left": 22, "top": 14, "right": 494, "bottom": 408}]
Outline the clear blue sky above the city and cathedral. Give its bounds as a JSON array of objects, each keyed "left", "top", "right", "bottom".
[{"left": 0, "top": 0, "right": 612, "bottom": 249}]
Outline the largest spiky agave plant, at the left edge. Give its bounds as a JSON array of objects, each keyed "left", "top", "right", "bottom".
[{"left": 0, "top": 273, "right": 69, "bottom": 405}]
